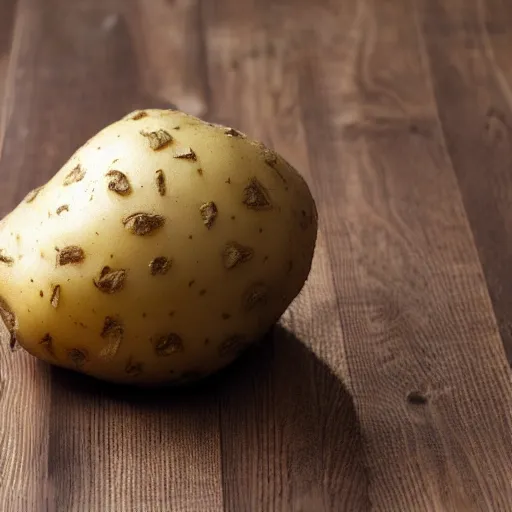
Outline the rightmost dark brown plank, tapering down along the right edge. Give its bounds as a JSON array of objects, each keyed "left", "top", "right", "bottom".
[{"left": 417, "top": 0, "right": 512, "bottom": 363}]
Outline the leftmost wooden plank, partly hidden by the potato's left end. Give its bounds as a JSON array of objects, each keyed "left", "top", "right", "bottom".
[{"left": 0, "top": 4, "right": 51, "bottom": 512}]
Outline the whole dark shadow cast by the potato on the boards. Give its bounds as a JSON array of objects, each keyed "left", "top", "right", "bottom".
[{"left": 51, "top": 326, "right": 367, "bottom": 512}]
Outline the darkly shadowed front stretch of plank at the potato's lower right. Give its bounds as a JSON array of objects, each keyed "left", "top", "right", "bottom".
[{"left": 218, "top": 326, "right": 370, "bottom": 512}]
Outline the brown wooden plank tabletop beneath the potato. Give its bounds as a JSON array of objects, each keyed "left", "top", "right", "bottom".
[{"left": 0, "top": 0, "right": 512, "bottom": 512}]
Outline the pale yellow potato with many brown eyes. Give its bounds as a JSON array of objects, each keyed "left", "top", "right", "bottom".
[{"left": 0, "top": 109, "right": 317, "bottom": 385}]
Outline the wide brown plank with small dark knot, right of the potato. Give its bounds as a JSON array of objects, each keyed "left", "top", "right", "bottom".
[{"left": 294, "top": 1, "right": 512, "bottom": 511}]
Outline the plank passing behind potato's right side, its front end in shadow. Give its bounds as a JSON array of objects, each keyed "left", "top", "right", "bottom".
[{"left": 204, "top": 0, "right": 369, "bottom": 512}]
